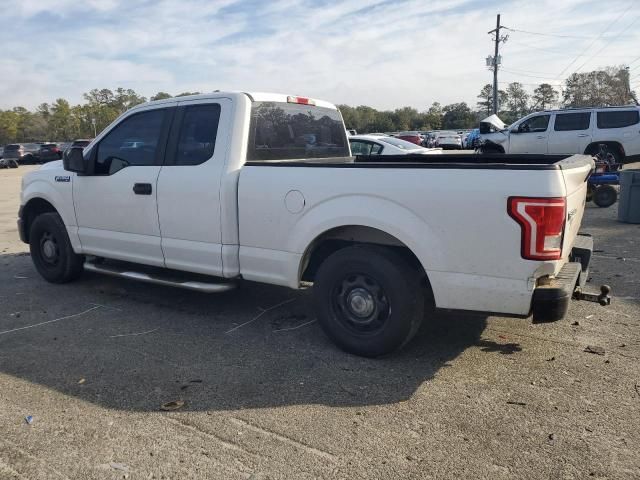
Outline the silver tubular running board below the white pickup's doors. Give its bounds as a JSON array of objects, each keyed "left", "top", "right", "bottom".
[{"left": 84, "top": 261, "right": 237, "bottom": 293}]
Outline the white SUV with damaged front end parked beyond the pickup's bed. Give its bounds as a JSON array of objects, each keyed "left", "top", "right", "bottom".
[{"left": 481, "top": 106, "right": 640, "bottom": 163}]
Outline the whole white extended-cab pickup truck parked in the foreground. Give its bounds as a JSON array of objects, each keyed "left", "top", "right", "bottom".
[{"left": 18, "top": 92, "right": 602, "bottom": 356}]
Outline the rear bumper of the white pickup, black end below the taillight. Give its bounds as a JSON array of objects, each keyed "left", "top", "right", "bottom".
[{"left": 531, "top": 235, "right": 593, "bottom": 323}]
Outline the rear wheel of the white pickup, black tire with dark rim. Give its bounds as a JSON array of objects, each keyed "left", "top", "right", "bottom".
[{"left": 313, "top": 246, "right": 425, "bottom": 357}]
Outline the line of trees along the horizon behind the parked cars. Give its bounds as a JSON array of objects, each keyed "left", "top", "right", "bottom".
[{"left": 0, "top": 67, "right": 637, "bottom": 145}]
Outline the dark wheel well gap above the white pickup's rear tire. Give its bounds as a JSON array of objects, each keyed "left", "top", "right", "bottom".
[{"left": 300, "top": 225, "right": 426, "bottom": 282}]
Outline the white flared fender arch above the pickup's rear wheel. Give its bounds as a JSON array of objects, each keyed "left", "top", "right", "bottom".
[{"left": 287, "top": 194, "right": 446, "bottom": 272}]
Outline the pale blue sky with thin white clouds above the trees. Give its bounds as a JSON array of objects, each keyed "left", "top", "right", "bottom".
[{"left": 0, "top": 0, "right": 640, "bottom": 110}]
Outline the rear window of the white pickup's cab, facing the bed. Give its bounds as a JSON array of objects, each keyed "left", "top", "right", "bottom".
[{"left": 247, "top": 102, "right": 350, "bottom": 161}]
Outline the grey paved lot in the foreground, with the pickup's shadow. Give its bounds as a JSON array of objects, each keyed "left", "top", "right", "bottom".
[{"left": 0, "top": 167, "right": 640, "bottom": 480}]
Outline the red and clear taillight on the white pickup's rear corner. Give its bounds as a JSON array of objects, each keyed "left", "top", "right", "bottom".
[{"left": 507, "top": 197, "right": 567, "bottom": 260}]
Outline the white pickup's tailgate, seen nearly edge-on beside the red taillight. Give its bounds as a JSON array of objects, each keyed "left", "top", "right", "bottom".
[{"left": 560, "top": 155, "right": 595, "bottom": 258}]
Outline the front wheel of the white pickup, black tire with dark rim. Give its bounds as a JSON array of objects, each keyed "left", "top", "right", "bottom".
[{"left": 29, "top": 212, "right": 84, "bottom": 283}]
